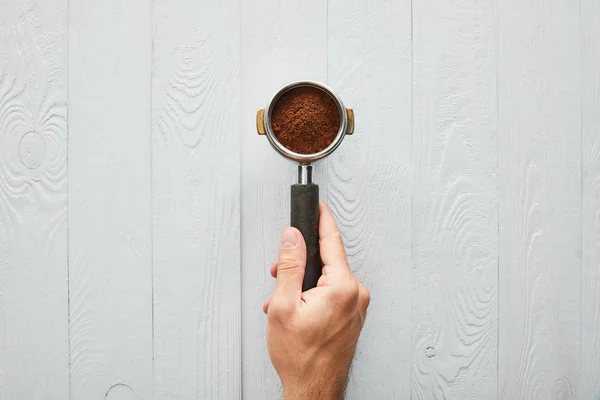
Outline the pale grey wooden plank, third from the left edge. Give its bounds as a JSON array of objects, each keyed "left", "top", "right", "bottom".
[{"left": 152, "top": 0, "right": 241, "bottom": 399}]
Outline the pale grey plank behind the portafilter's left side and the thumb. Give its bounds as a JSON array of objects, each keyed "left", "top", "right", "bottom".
[{"left": 241, "top": 0, "right": 327, "bottom": 399}]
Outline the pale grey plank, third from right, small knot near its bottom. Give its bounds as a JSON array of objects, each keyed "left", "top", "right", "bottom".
[{"left": 412, "top": 0, "right": 498, "bottom": 399}]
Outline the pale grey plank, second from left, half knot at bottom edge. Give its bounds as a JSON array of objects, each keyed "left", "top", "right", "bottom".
[{"left": 69, "top": 0, "right": 153, "bottom": 400}]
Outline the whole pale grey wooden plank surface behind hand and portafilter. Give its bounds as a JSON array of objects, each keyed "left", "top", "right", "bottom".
[{"left": 0, "top": 0, "right": 600, "bottom": 400}]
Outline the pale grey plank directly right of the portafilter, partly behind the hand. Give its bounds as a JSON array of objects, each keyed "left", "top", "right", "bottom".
[{"left": 327, "top": 0, "right": 412, "bottom": 399}]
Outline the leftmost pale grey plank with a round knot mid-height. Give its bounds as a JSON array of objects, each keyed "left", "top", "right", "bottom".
[{"left": 0, "top": 0, "right": 69, "bottom": 400}]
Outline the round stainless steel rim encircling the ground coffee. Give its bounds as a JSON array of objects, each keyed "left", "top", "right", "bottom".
[{"left": 264, "top": 81, "right": 348, "bottom": 164}]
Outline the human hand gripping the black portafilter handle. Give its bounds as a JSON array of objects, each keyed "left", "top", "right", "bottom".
[{"left": 263, "top": 202, "right": 370, "bottom": 400}]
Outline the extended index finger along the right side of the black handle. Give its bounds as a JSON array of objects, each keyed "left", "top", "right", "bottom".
[{"left": 319, "top": 201, "right": 349, "bottom": 270}]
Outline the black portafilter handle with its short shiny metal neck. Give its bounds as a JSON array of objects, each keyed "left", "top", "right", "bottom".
[{"left": 290, "top": 165, "right": 322, "bottom": 292}]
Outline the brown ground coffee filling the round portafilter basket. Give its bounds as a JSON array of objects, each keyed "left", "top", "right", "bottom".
[{"left": 271, "top": 87, "right": 340, "bottom": 154}]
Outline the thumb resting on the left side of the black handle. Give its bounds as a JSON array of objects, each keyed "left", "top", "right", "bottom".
[{"left": 273, "top": 227, "right": 306, "bottom": 306}]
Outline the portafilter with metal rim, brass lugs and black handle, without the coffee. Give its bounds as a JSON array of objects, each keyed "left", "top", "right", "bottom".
[{"left": 256, "top": 81, "right": 354, "bottom": 291}]
